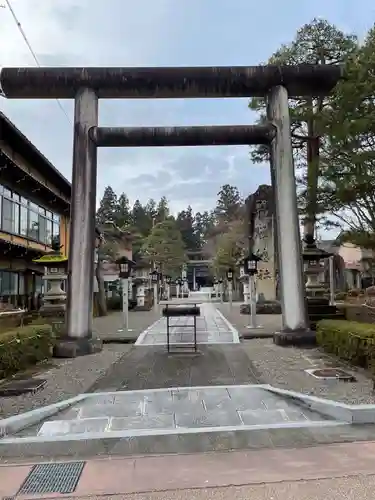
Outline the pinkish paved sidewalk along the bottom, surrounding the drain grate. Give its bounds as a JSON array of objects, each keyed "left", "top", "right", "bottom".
[{"left": 0, "top": 442, "right": 375, "bottom": 500}]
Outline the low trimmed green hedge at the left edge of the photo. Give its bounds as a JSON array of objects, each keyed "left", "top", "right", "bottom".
[{"left": 0, "top": 325, "right": 55, "bottom": 378}]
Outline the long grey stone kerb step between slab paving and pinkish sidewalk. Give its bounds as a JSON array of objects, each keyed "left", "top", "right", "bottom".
[{"left": 0, "top": 421, "right": 352, "bottom": 461}]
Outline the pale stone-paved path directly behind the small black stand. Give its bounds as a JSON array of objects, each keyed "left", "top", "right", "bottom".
[{"left": 136, "top": 297, "right": 239, "bottom": 346}]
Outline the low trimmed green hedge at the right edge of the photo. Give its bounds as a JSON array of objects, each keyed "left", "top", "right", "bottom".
[{"left": 316, "top": 319, "right": 375, "bottom": 369}]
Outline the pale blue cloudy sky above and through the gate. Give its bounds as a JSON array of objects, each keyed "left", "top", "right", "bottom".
[{"left": 0, "top": 0, "right": 375, "bottom": 215}]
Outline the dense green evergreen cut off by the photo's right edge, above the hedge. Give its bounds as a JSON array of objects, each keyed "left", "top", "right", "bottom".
[{"left": 320, "top": 26, "right": 375, "bottom": 249}]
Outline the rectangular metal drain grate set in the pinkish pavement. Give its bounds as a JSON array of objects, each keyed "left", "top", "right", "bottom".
[{"left": 17, "top": 462, "right": 85, "bottom": 495}]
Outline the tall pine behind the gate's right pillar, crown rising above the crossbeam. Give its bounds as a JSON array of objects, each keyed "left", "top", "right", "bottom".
[{"left": 250, "top": 19, "right": 357, "bottom": 235}]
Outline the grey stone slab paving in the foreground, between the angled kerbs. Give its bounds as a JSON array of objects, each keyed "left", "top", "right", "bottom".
[{"left": 29, "top": 385, "right": 327, "bottom": 439}]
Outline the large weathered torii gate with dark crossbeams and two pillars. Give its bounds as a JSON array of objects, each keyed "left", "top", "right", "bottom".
[{"left": 0, "top": 65, "right": 342, "bottom": 354}]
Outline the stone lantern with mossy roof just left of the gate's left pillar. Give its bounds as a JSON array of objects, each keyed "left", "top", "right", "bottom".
[{"left": 33, "top": 251, "right": 68, "bottom": 317}]
